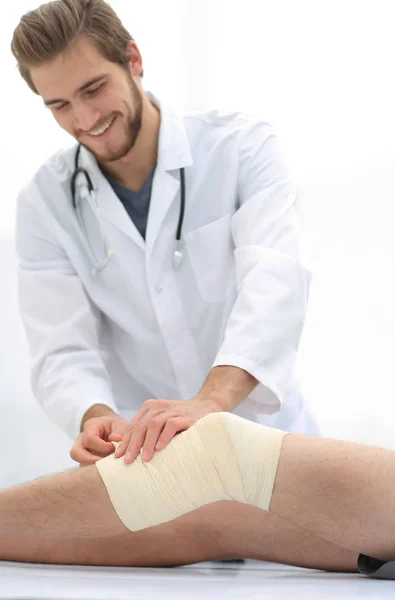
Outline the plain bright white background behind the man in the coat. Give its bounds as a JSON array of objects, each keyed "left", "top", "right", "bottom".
[{"left": 0, "top": 0, "right": 395, "bottom": 485}]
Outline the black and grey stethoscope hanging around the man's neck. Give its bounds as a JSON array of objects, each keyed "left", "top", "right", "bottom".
[{"left": 70, "top": 144, "right": 185, "bottom": 274}]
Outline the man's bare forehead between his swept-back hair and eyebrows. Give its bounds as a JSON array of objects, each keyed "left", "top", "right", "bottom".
[{"left": 30, "top": 39, "right": 117, "bottom": 99}]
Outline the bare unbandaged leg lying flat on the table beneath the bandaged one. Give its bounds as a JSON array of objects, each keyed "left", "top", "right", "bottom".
[{"left": 0, "top": 494, "right": 357, "bottom": 572}]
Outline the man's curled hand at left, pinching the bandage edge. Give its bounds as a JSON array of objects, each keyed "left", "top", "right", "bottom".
[{"left": 70, "top": 415, "right": 129, "bottom": 467}]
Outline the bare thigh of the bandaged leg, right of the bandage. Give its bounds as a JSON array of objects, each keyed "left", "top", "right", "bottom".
[{"left": 270, "top": 434, "right": 395, "bottom": 561}]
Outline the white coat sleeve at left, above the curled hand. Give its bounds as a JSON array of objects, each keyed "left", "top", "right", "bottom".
[{"left": 16, "top": 188, "right": 117, "bottom": 440}]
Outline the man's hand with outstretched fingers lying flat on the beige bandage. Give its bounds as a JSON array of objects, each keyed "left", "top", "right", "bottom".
[{"left": 115, "top": 398, "right": 223, "bottom": 463}]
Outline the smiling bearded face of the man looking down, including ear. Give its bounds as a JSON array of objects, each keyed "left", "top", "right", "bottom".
[{"left": 30, "top": 39, "right": 143, "bottom": 162}]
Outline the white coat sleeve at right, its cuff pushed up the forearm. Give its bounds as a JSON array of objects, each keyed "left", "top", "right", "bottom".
[{"left": 213, "top": 123, "right": 311, "bottom": 414}]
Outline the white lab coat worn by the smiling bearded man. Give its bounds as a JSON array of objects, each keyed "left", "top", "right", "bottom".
[{"left": 16, "top": 95, "right": 318, "bottom": 439}]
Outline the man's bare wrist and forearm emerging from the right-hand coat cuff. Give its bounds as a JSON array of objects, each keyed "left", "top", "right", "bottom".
[{"left": 197, "top": 366, "right": 259, "bottom": 412}]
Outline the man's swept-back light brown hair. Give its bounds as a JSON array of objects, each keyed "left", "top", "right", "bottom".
[{"left": 11, "top": 0, "right": 143, "bottom": 94}]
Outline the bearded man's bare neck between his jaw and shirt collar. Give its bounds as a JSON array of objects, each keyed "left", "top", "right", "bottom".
[{"left": 100, "top": 94, "right": 160, "bottom": 191}]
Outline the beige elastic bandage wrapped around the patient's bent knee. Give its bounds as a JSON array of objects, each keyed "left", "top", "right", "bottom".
[{"left": 96, "top": 412, "right": 286, "bottom": 531}]
